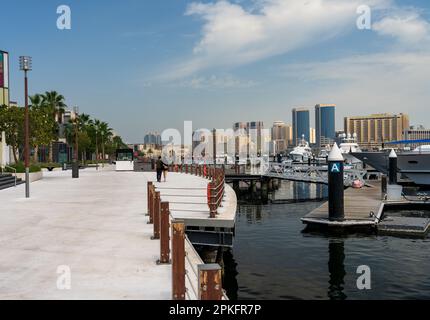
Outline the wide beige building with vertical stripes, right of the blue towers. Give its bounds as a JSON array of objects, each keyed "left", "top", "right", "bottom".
[{"left": 345, "top": 113, "right": 409, "bottom": 149}]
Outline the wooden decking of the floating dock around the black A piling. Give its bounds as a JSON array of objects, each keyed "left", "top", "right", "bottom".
[{"left": 302, "top": 185, "right": 383, "bottom": 226}]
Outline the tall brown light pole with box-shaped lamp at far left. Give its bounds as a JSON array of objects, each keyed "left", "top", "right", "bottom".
[{"left": 19, "top": 56, "right": 32, "bottom": 198}]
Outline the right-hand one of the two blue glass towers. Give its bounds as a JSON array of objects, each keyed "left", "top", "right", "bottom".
[{"left": 315, "top": 104, "right": 336, "bottom": 148}]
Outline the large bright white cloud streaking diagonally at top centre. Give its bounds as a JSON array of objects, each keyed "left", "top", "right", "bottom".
[{"left": 159, "top": 0, "right": 390, "bottom": 79}]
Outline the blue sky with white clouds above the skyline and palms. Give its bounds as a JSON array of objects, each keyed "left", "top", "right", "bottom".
[{"left": 0, "top": 0, "right": 430, "bottom": 143}]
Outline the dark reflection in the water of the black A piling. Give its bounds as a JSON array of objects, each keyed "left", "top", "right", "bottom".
[{"left": 328, "top": 240, "right": 346, "bottom": 300}]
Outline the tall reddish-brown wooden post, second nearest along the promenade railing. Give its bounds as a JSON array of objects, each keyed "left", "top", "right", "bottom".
[{"left": 172, "top": 220, "right": 185, "bottom": 300}]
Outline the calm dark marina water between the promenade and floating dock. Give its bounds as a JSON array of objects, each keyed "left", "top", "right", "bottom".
[{"left": 224, "top": 182, "right": 430, "bottom": 299}]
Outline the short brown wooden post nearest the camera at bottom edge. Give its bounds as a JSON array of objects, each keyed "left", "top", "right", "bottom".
[{"left": 198, "top": 264, "right": 223, "bottom": 300}]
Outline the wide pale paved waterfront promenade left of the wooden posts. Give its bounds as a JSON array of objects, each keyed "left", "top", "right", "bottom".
[{"left": 0, "top": 168, "right": 168, "bottom": 299}]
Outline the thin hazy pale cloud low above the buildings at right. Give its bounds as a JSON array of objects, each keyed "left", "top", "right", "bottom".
[{"left": 283, "top": 52, "right": 430, "bottom": 123}]
